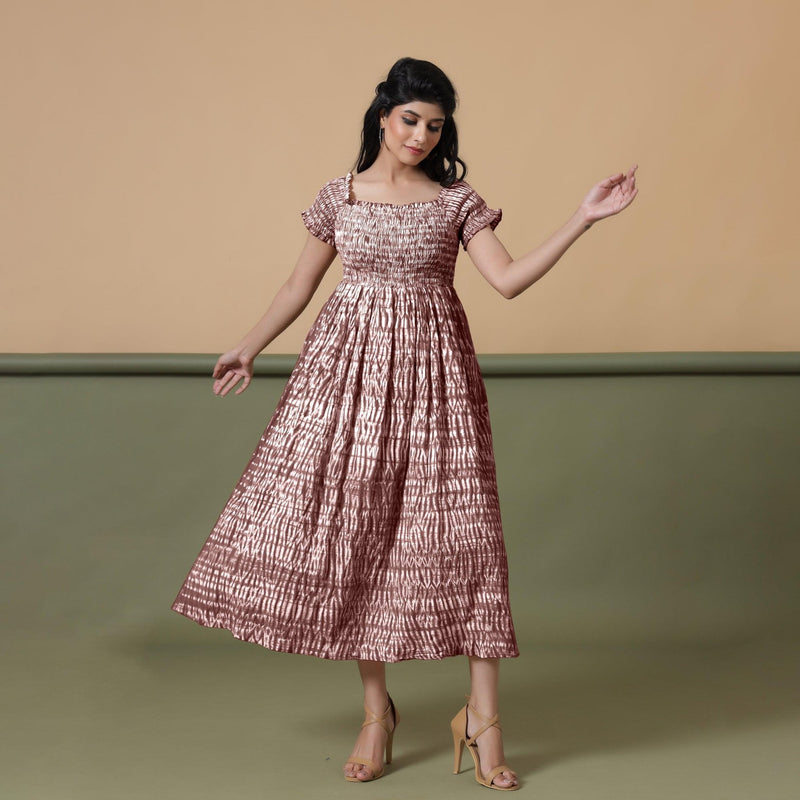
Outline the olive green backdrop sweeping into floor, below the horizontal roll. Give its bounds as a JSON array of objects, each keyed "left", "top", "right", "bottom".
[{"left": 0, "top": 356, "right": 800, "bottom": 800}]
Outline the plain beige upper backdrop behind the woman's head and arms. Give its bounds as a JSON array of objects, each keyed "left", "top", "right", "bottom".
[{"left": 0, "top": 0, "right": 800, "bottom": 353}]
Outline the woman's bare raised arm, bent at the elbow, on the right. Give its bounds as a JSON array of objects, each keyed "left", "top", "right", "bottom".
[{"left": 467, "top": 165, "right": 639, "bottom": 300}]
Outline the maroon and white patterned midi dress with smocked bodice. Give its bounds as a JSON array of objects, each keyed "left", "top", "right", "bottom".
[{"left": 172, "top": 174, "right": 519, "bottom": 661}]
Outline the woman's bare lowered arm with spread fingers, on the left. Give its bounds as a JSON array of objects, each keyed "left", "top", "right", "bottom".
[{"left": 213, "top": 233, "right": 336, "bottom": 395}]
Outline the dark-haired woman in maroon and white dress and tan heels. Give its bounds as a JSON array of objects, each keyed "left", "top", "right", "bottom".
[{"left": 172, "top": 58, "right": 637, "bottom": 790}]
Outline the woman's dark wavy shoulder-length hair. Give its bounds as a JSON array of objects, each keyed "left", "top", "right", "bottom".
[{"left": 356, "top": 58, "right": 467, "bottom": 186}]
